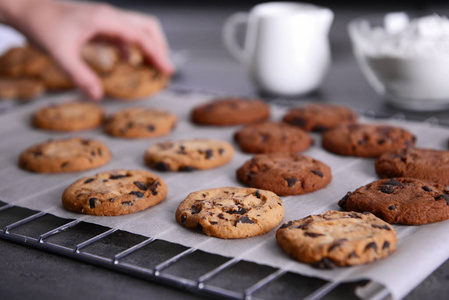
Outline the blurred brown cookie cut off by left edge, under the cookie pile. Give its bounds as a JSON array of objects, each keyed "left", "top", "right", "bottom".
[{"left": 0, "top": 78, "right": 45, "bottom": 100}]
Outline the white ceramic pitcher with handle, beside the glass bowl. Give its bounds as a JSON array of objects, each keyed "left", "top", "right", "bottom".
[{"left": 223, "top": 2, "right": 334, "bottom": 96}]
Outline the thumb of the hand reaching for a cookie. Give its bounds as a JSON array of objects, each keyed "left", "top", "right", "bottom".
[{"left": 53, "top": 51, "right": 103, "bottom": 100}]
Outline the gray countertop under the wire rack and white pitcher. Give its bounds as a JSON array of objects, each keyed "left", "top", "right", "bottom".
[{"left": 0, "top": 2, "right": 449, "bottom": 300}]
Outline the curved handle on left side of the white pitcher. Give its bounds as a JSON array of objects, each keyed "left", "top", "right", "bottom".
[{"left": 223, "top": 12, "right": 248, "bottom": 63}]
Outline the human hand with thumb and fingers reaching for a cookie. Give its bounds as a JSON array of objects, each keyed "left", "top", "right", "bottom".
[{"left": 10, "top": 0, "right": 173, "bottom": 100}]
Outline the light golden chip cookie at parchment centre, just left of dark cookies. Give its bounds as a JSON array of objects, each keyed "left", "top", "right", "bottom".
[{"left": 145, "top": 139, "right": 234, "bottom": 171}]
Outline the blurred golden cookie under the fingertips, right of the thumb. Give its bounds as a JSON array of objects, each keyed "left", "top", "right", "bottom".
[{"left": 101, "top": 63, "right": 169, "bottom": 100}]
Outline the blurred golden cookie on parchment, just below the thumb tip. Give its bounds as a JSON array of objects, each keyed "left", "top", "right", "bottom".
[{"left": 33, "top": 101, "right": 105, "bottom": 131}]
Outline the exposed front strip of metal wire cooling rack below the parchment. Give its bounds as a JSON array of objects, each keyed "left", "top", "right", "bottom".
[{"left": 0, "top": 201, "right": 368, "bottom": 300}]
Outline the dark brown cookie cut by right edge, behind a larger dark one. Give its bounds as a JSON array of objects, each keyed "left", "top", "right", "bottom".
[{"left": 376, "top": 148, "right": 449, "bottom": 186}]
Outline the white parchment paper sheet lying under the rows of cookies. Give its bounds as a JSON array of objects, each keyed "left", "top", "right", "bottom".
[{"left": 0, "top": 91, "right": 449, "bottom": 298}]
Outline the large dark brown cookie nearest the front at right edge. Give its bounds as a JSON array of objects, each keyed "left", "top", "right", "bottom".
[{"left": 338, "top": 178, "right": 449, "bottom": 225}]
